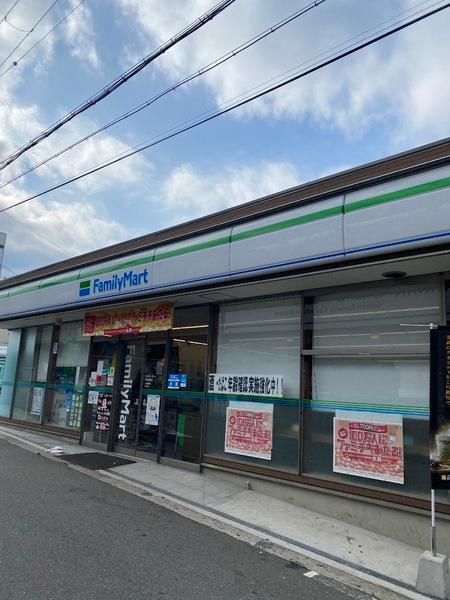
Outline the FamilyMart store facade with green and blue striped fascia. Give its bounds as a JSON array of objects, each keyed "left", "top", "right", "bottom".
[{"left": 0, "top": 141, "right": 450, "bottom": 548}]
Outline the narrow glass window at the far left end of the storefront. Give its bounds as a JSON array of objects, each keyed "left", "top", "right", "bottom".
[{"left": 12, "top": 325, "right": 53, "bottom": 423}]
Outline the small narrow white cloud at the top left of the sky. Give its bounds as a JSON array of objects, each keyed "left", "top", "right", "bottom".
[{"left": 64, "top": 0, "right": 101, "bottom": 70}]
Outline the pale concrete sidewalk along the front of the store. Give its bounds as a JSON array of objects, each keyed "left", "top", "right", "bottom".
[{"left": 0, "top": 424, "right": 436, "bottom": 599}]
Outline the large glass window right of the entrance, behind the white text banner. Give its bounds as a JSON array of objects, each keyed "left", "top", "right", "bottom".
[{"left": 206, "top": 297, "right": 301, "bottom": 472}]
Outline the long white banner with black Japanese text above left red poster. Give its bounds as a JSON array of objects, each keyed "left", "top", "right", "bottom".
[{"left": 208, "top": 373, "right": 283, "bottom": 398}]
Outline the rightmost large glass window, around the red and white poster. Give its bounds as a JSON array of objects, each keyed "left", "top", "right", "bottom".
[{"left": 303, "top": 281, "right": 440, "bottom": 495}]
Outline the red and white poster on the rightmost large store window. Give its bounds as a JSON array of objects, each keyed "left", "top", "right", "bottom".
[{"left": 333, "top": 417, "right": 404, "bottom": 483}]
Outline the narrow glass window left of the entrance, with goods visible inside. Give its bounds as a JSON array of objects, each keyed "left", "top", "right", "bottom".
[{"left": 45, "top": 322, "right": 90, "bottom": 429}]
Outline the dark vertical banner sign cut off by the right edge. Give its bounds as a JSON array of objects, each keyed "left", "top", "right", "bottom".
[{"left": 430, "top": 327, "right": 450, "bottom": 490}]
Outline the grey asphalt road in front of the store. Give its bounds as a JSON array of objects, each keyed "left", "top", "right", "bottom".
[{"left": 0, "top": 440, "right": 365, "bottom": 600}]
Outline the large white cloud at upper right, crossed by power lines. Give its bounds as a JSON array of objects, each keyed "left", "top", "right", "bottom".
[{"left": 118, "top": 0, "right": 450, "bottom": 144}]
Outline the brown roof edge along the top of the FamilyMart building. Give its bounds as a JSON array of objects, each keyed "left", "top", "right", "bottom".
[{"left": 0, "top": 138, "right": 450, "bottom": 289}]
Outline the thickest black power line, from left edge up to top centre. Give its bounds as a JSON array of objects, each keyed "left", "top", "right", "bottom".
[{"left": 0, "top": 0, "right": 235, "bottom": 170}]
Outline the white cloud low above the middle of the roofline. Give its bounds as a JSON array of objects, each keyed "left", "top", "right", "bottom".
[{"left": 160, "top": 162, "right": 300, "bottom": 224}]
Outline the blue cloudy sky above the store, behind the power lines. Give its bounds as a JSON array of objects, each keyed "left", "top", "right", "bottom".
[{"left": 0, "top": 0, "right": 450, "bottom": 277}]
